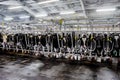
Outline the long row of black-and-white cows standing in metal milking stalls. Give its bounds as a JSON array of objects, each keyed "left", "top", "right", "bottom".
[{"left": 0, "top": 32, "right": 120, "bottom": 60}]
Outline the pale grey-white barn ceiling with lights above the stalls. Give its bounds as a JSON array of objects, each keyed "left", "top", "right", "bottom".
[{"left": 0, "top": 0, "right": 120, "bottom": 30}]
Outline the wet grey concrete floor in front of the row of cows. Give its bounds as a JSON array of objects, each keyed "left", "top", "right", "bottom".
[{"left": 0, "top": 56, "right": 120, "bottom": 80}]
